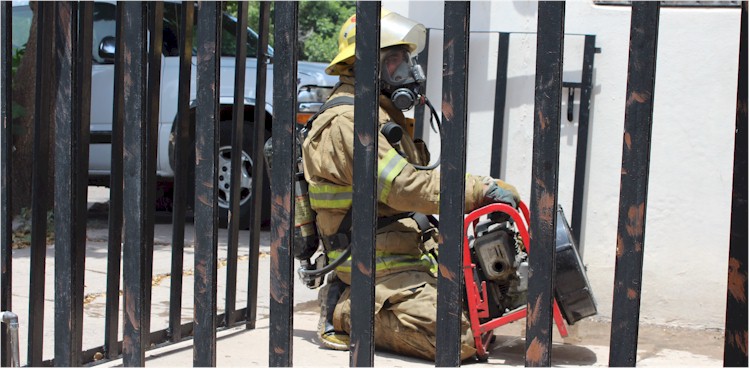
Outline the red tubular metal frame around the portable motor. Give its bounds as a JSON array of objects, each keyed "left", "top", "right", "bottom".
[{"left": 463, "top": 202, "right": 568, "bottom": 359}]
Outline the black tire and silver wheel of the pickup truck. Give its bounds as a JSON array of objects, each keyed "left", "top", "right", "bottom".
[{"left": 217, "top": 120, "right": 271, "bottom": 229}]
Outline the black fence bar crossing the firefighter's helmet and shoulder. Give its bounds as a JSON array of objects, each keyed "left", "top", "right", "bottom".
[{"left": 349, "top": 1, "right": 380, "bottom": 367}]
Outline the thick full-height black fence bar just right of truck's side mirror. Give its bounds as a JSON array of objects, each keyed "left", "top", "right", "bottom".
[{"left": 122, "top": 2, "right": 148, "bottom": 366}]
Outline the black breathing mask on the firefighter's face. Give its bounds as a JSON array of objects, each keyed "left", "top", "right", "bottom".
[{"left": 380, "top": 47, "right": 425, "bottom": 111}]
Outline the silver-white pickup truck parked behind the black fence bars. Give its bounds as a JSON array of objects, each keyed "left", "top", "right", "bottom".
[{"left": 12, "top": 1, "right": 338, "bottom": 225}]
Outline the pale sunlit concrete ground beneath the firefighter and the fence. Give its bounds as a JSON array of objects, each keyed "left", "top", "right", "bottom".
[{"left": 2, "top": 188, "right": 723, "bottom": 367}]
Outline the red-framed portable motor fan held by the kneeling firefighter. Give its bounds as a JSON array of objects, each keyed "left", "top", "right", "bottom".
[{"left": 463, "top": 202, "right": 597, "bottom": 360}]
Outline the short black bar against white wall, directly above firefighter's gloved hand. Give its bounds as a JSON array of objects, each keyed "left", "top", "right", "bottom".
[{"left": 490, "top": 32, "right": 510, "bottom": 178}]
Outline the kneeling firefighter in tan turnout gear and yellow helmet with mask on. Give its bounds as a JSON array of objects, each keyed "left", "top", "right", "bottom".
[{"left": 302, "top": 10, "right": 519, "bottom": 360}]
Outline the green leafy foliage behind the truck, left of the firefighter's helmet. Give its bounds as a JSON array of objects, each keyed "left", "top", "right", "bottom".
[{"left": 225, "top": 1, "right": 356, "bottom": 62}]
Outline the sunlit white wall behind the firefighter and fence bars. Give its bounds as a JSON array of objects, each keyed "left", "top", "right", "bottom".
[{"left": 390, "top": 0, "right": 740, "bottom": 328}]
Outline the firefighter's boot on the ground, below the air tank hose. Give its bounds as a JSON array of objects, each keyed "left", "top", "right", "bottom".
[{"left": 318, "top": 274, "right": 349, "bottom": 351}]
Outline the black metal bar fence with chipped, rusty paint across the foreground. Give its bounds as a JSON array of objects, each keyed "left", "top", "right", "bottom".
[{"left": 0, "top": 1, "right": 748, "bottom": 366}]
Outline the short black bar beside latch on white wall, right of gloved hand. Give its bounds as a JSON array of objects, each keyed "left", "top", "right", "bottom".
[{"left": 571, "top": 35, "right": 596, "bottom": 252}]
